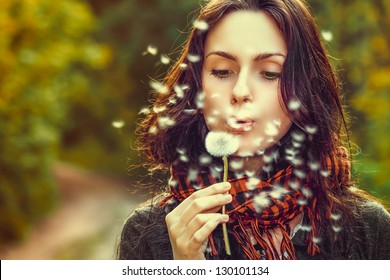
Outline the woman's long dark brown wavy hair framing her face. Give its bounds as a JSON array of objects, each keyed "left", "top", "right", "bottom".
[{"left": 137, "top": 0, "right": 374, "bottom": 258}]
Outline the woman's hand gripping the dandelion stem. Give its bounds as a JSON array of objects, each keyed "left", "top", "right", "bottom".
[{"left": 165, "top": 182, "right": 232, "bottom": 260}]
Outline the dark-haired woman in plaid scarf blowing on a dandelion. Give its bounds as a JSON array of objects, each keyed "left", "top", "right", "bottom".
[{"left": 119, "top": 0, "right": 390, "bottom": 259}]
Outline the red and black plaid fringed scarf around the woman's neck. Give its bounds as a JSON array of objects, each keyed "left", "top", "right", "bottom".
[{"left": 160, "top": 147, "right": 351, "bottom": 259}]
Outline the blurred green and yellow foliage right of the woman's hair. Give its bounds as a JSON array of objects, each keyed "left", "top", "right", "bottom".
[{"left": 308, "top": 0, "right": 390, "bottom": 203}]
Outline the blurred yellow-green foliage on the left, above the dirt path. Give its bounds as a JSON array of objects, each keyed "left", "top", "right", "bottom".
[{"left": 0, "top": 0, "right": 110, "bottom": 242}]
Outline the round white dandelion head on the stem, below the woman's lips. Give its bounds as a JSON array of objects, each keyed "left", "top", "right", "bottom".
[{"left": 205, "top": 131, "right": 240, "bottom": 157}]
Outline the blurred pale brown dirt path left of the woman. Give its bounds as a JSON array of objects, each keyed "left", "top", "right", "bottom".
[{"left": 0, "top": 164, "right": 145, "bottom": 260}]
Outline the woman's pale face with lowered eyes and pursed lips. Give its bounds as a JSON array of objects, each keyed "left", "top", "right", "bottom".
[{"left": 202, "top": 11, "right": 291, "bottom": 156}]
